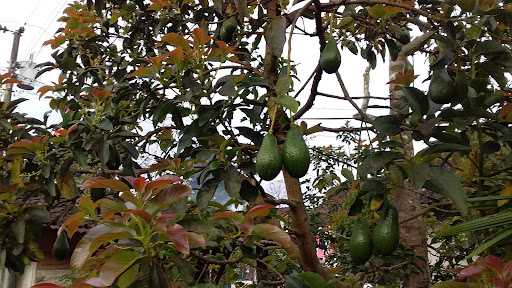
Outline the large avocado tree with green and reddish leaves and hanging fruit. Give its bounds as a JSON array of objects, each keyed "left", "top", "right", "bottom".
[{"left": 0, "top": 0, "right": 512, "bottom": 287}]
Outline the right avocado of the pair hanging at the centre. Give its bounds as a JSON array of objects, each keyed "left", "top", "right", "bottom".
[{"left": 283, "top": 127, "right": 310, "bottom": 178}]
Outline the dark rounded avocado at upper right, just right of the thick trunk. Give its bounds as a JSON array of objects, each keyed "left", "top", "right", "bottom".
[{"left": 428, "top": 68, "right": 457, "bottom": 104}]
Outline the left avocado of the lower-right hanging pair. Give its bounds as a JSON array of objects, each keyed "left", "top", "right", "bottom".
[{"left": 349, "top": 222, "right": 372, "bottom": 264}]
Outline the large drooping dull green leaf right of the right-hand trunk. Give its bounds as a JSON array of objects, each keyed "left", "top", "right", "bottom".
[{"left": 426, "top": 167, "right": 468, "bottom": 215}]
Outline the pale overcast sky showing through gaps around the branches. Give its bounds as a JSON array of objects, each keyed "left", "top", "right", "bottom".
[{"left": 0, "top": 0, "right": 432, "bottom": 144}]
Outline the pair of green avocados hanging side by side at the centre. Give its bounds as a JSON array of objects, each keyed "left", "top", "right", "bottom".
[{"left": 256, "top": 127, "right": 310, "bottom": 181}]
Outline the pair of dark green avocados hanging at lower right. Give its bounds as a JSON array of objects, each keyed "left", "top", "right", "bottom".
[{"left": 350, "top": 207, "right": 400, "bottom": 265}]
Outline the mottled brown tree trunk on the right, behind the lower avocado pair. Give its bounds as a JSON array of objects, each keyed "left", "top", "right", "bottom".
[{"left": 389, "top": 57, "right": 430, "bottom": 288}]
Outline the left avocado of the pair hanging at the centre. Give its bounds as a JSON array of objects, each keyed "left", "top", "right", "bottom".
[{"left": 256, "top": 133, "right": 283, "bottom": 181}]
